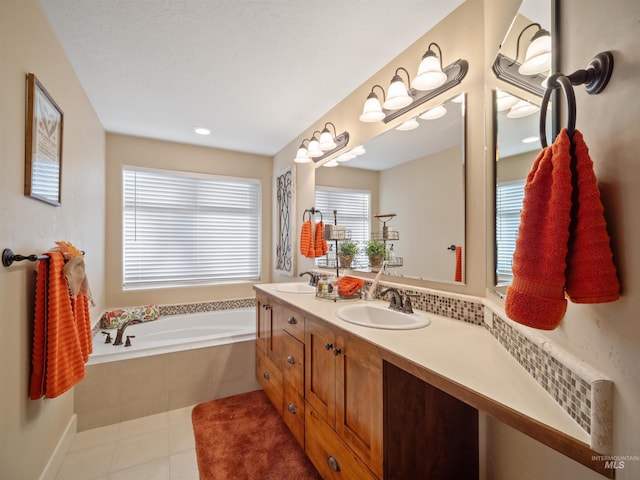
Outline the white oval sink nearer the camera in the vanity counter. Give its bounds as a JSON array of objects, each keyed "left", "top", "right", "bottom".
[{"left": 336, "top": 303, "right": 431, "bottom": 330}]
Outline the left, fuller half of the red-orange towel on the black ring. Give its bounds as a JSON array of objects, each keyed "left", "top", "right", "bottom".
[{"left": 505, "top": 129, "right": 572, "bottom": 330}]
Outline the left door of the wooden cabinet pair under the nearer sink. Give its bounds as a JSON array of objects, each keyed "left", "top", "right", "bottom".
[{"left": 304, "top": 318, "right": 337, "bottom": 428}]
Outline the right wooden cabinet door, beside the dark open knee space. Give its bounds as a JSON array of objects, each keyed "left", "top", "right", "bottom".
[{"left": 335, "top": 336, "right": 383, "bottom": 478}]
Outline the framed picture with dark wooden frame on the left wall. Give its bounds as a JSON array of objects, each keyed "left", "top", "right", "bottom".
[{"left": 24, "top": 73, "right": 64, "bottom": 206}]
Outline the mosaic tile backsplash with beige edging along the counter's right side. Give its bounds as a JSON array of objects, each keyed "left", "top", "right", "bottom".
[{"left": 367, "top": 284, "right": 613, "bottom": 453}]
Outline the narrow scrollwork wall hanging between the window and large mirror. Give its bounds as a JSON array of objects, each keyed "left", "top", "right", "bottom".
[{"left": 276, "top": 167, "right": 293, "bottom": 275}]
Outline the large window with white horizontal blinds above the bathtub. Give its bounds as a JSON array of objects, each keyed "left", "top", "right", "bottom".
[{"left": 123, "top": 167, "right": 260, "bottom": 289}]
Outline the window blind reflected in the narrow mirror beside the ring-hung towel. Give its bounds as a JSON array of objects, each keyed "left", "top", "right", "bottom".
[{"left": 496, "top": 181, "right": 524, "bottom": 285}]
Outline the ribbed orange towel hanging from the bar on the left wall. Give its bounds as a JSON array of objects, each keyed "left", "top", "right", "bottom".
[{"left": 29, "top": 252, "right": 90, "bottom": 400}]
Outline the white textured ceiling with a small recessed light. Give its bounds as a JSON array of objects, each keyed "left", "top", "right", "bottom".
[{"left": 40, "top": 0, "right": 462, "bottom": 155}]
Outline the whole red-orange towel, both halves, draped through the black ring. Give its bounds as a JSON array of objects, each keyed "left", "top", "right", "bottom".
[{"left": 505, "top": 129, "right": 619, "bottom": 330}]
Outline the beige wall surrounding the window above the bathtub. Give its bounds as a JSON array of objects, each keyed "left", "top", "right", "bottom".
[{"left": 105, "top": 134, "right": 273, "bottom": 307}]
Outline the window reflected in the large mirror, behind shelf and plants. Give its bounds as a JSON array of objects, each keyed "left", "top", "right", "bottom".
[{"left": 315, "top": 186, "right": 371, "bottom": 268}]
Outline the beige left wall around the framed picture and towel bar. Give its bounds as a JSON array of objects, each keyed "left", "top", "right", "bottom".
[{"left": 0, "top": 0, "right": 105, "bottom": 480}]
